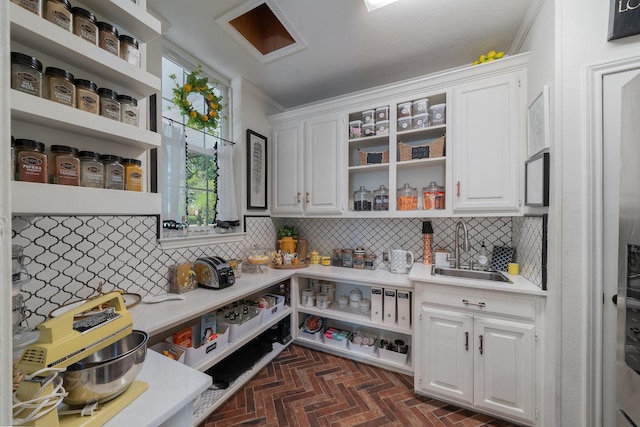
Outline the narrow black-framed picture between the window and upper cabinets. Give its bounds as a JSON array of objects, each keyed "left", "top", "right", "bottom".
[{"left": 247, "top": 129, "right": 268, "bottom": 209}]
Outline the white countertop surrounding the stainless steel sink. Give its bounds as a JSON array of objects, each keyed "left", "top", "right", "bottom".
[{"left": 409, "top": 263, "right": 547, "bottom": 296}]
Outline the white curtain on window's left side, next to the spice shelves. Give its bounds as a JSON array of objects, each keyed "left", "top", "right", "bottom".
[{"left": 162, "top": 122, "right": 187, "bottom": 221}]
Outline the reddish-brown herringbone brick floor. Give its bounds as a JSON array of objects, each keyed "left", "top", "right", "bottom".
[{"left": 201, "top": 345, "right": 513, "bottom": 427}]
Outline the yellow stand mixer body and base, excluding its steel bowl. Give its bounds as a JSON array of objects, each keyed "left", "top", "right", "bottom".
[{"left": 13, "top": 292, "right": 148, "bottom": 427}]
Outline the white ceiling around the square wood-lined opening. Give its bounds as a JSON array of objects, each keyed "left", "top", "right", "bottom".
[{"left": 147, "top": 0, "right": 541, "bottom": 108}]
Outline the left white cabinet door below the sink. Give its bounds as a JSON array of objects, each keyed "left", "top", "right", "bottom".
[{"left": 416, "top": 306, "right": 473, "bottom": 404}]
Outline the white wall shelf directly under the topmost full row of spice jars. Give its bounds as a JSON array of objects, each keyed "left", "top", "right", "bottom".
[{"left": 9, "top": 0, "right": 162, "bottom": 96}]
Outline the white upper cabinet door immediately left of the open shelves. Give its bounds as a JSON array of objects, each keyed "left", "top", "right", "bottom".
[{"left": 304, "top": 116, "right": 342, "bottom": 213}]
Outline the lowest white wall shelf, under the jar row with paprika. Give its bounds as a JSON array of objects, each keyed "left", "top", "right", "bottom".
[{"left": 11, "top": 181, "right": 161, "bottom": 215}]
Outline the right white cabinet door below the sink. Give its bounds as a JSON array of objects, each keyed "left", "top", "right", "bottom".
[{"left": 474, "top": 317, "right": 536, "bottom": 422}]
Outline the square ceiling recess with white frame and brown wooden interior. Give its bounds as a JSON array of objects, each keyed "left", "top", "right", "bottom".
[{"left": 216, "top": 0, "right": 306, "bottom": 64}]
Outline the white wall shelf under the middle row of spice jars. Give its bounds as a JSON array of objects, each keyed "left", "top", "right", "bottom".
[{"left": 10, "top": 89, "right": 162, "bottom": 150}]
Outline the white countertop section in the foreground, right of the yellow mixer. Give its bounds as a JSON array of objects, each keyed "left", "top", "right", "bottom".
[{"left": 105, "top": 349, "right": 212, "bottom": 427}]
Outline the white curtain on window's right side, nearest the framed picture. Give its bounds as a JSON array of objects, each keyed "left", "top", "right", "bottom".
[{"left": 218, "top": 141, "right": 240, "bottom": 221}]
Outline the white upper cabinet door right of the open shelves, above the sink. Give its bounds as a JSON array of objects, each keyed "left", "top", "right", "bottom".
[{"left": 450, "top": 72, "right": 524, "bottom": 216}]
